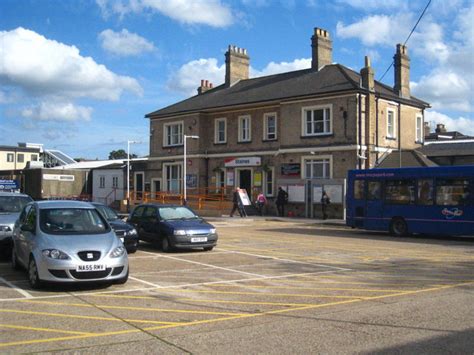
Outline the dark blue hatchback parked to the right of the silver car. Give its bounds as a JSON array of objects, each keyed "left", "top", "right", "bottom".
[{"left": 128, "top": 204, "right": 218, "bottom": 252}]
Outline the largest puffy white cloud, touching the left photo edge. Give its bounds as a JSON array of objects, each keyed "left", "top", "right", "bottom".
[{"left": 0, "top": 27, "right": 142, "bottom": 100}]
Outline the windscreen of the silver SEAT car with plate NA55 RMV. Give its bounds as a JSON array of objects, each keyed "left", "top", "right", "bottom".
[{"left": 40, "top": 208, "right": 110, "bottom": 234}]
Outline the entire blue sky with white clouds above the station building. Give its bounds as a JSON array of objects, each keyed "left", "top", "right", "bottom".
[{"left": 0, "top": 0, "right": 474, "bottom": 159}]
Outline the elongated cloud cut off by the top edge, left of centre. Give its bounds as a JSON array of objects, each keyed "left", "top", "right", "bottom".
[{"left": 96, "top": 0, "right": 234, "bottom": 27}]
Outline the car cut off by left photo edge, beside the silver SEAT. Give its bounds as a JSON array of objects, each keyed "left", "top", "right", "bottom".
[{"left": 0, "top": 192, "right": 33, "bottom": 256}]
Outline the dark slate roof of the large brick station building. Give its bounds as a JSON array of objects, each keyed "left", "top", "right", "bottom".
[{"left": 145, "top": 64, "right": 429, "bottom": 118}]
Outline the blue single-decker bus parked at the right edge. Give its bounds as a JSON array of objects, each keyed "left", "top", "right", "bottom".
[{"left": 346, "top": 165, "right": 474, "bottom": 236}]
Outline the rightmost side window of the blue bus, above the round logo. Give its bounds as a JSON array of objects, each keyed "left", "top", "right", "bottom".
[{"left": 436, "top": 179, "right": 469, "bottom": 206}]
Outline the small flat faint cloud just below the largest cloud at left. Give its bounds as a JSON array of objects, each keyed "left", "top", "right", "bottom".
[{"left": 19, "top": 102, "right": 92, "bottom": 122}]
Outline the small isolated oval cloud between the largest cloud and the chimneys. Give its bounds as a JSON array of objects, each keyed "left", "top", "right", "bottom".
[{"left": 99, "top": 29, "right": 156, "bottom": 56}]
